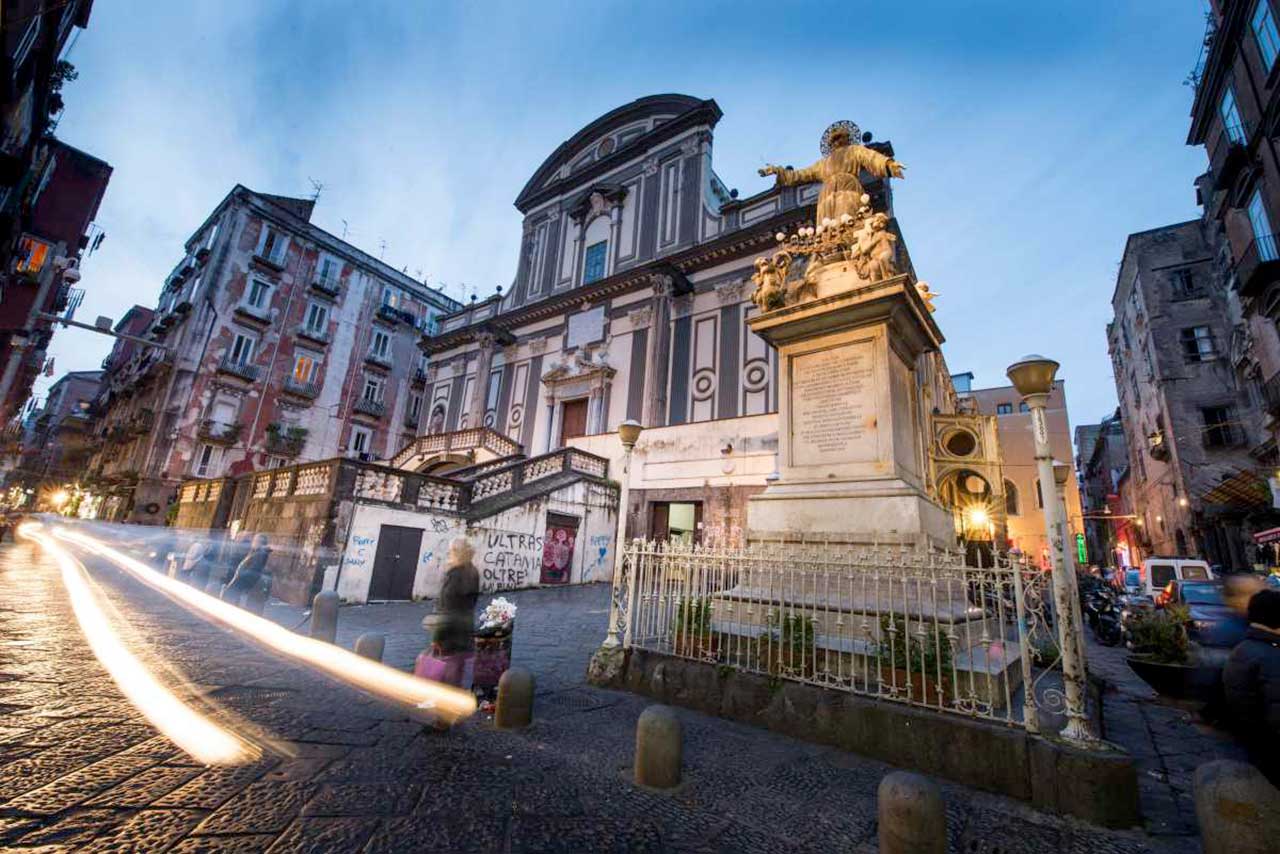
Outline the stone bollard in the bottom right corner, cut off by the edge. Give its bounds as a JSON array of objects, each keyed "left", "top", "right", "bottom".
[{"left": 1192, "top": 759, "right": 1280, "bottom": 854}]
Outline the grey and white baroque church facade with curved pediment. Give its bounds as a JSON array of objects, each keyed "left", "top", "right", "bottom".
[{"left": 421, "top": 95, "right": 967, "bottom": 542}]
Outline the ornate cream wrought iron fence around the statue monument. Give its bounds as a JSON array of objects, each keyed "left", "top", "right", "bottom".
[{"left": 613, "top": 540, "right": 1066, "bottom": 731}]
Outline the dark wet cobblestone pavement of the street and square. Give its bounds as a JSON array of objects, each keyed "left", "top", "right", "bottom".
[{"left": 0, "top": 530, "right": 1228, "bottom": 854}]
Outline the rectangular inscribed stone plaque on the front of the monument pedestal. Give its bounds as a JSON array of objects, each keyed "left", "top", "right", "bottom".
[{"left": 791, "top": 341, "right": 877, "bottom": 466}]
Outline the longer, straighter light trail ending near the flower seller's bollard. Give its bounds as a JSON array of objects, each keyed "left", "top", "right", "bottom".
[{"left": 54, "top": 529, "right": 476, "bottom": 721}]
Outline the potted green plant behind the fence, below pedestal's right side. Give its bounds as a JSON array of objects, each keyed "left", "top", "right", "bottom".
[{"left": 876, "top": 615, "right": 955, "bottom": 705}]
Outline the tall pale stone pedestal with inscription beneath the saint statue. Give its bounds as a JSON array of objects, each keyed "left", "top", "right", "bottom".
[{"left": 748, "top": 267, "right": 955, "bottom": 547}]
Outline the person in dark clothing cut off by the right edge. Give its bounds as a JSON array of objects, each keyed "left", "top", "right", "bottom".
[{"left": 1222, "top": 590, "right": 1280, "bottom": 786}]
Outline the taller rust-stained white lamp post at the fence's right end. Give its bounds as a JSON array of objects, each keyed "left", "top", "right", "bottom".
[{"left": 1007, "top": 356, "right": 1094, "bottom": 741}]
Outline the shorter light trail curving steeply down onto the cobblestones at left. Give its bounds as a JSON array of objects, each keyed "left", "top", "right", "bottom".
[{"left": 18, "top": 522, "right": 261, "bottom": 766}]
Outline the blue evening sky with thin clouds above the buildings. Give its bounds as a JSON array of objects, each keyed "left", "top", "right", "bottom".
[{"left": 41, "top": 0, "right": 1206, "bottom": 435}]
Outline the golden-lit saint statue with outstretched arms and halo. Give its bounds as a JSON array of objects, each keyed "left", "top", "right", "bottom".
[{"left": 760, "top": 120, "right": 902, "bottom": 225}]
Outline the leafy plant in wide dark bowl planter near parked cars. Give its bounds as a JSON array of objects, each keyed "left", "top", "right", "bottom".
[{"left": 1128, "top": 606, "right": 1222, "bottom": 700}]
